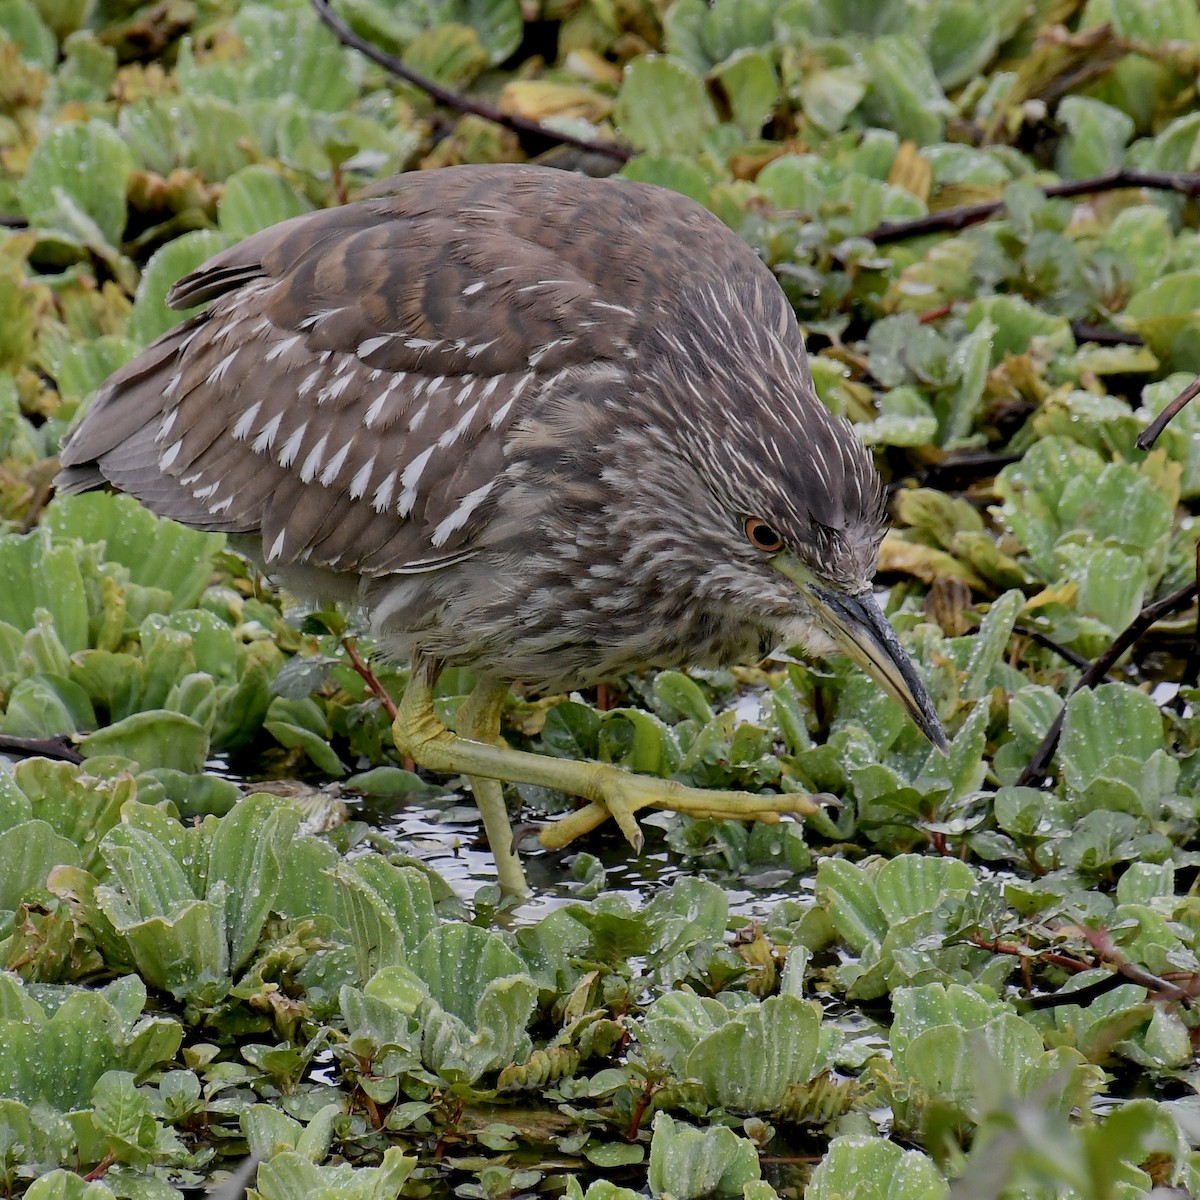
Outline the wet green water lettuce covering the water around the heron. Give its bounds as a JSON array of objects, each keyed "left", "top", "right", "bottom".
[{"left": 0, "top": 0, "right": 1200, "bottom": 1200}]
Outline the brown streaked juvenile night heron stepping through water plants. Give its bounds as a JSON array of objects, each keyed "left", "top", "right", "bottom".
[{"left": 58, "top": 166, "right": 946, "bottom": 890}]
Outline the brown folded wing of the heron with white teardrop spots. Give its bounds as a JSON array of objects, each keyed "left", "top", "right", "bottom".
[{"left": 60, "top": 173, "right": 636, "bottom": 574}]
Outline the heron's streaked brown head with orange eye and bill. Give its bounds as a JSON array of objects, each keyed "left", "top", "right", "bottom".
[{"left": 652, "top": 319, "right": 947, "bottom": 750}]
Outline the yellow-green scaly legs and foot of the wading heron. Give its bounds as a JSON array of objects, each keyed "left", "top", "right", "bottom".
[{"left": 391, "top": 655, "right": 821, "bottom": 890}]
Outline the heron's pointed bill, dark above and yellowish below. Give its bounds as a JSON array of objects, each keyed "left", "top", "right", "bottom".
[{"left": 805, "top": 586, "right": 949, "bottom": 750}]
